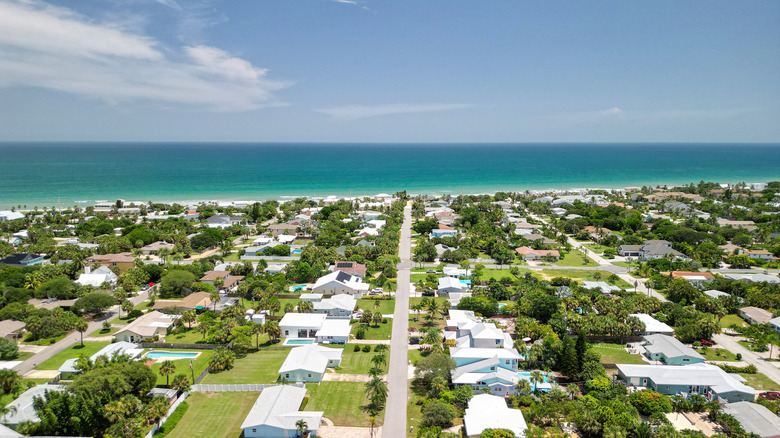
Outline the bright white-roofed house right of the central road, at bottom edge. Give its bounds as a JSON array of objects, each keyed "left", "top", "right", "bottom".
[{"left": 463, "top": 394, "right": 528, "bottom": 438}]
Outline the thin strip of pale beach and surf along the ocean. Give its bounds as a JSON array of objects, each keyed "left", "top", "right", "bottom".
[{"left": 0, "top": 177, "right": 780, "bottom": 212}]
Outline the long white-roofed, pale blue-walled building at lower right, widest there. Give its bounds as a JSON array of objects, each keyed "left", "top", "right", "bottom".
[{"left": 617, "top": 363, "right": 756, "bottom": 403}]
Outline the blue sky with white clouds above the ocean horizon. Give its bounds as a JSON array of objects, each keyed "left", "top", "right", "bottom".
[{"left": 0, "top": 0, "right": 780, "bottom": 143}]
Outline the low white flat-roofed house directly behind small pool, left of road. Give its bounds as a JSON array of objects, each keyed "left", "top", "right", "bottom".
[{"left": 279, "top": 313, "right": 352, "bottom": 344}]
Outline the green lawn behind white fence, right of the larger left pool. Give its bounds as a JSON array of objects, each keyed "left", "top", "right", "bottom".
[{"left": 203, "top": 344, "right": 290, "bottom": 384}]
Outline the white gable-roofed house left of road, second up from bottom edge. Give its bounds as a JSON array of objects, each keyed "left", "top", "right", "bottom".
[{"left": 279, "top": 344, "right": 344, "bottom": 383}]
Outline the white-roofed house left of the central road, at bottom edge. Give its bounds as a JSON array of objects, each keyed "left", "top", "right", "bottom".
[{"left": 241, "top": 385, "right": 323, "bottom": 438}]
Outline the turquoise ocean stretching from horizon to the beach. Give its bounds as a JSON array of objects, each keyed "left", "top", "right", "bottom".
[{"left": 0, "top": 142, "right": 780, "bottom": 208}]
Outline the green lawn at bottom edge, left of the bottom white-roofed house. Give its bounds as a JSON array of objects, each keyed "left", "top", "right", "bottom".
[{"left": 168, "top": 392, "right": 260, "bottom": 438}]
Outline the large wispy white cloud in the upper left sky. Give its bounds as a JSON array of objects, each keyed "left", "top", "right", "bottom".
[{"left": 0, "top": 0, "right": 291, "bottom": 111}]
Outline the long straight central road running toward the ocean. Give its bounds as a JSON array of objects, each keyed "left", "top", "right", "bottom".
[{"left": 382, "top": 204, "right": 412, "bottom": 438}]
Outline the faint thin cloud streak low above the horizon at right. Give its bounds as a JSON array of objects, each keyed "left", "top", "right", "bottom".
[{"left": 552, "top": 107, "right": 754, "bottom": 124}]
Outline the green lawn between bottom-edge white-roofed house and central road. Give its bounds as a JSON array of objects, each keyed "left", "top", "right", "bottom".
[{"left": 304, "top": 382, "right": 384, "bottom": 427}]
